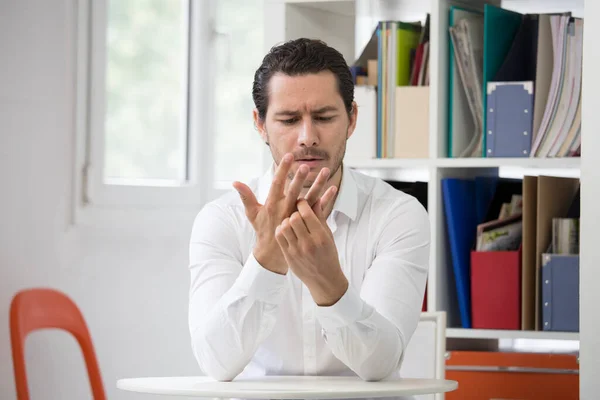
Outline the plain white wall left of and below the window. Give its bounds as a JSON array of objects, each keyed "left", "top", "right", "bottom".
[{"left": 0, "top": 0, "right": 199, "bottom": 400}]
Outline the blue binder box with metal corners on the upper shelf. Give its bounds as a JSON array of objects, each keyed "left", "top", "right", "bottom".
[{"left": 485, "top": 81, "right": 533, "bottom": 157}]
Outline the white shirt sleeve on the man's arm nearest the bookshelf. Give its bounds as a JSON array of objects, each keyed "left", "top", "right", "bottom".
[{"left": 317, "top": 200, "right": 430, "bottom": 381}]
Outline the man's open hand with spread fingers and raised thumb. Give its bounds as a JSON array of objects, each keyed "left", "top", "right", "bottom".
[{"left": 233, "top": 154, "right": 335, "bottom": 274}]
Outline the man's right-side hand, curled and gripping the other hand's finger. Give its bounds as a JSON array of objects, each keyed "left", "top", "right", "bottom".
[{"left": 275, "top": 200, "right": 348, "bottom": 306}]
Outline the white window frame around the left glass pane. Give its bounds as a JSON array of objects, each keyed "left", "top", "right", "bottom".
[{"left": 72, "top": 0, "right": 226, "bottom": 228}]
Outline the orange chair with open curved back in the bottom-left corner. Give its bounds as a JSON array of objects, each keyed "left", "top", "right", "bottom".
[{"left": 10, "top": 288, "right": 106, "bottom": 400}]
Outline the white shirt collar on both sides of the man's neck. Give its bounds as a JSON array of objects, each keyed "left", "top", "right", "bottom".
[{"left": 257, "top": 163, "right": 358, "bottom": 220}]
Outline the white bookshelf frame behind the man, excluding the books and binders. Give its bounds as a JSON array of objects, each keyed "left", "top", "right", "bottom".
[{"left": 265, "top": 0, "right": 585, "bottom": 340}]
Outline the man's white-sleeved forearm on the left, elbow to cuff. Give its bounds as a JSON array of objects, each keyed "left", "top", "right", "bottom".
[{"left": 190, "top": 257, "right": 286, "bottom": 381}]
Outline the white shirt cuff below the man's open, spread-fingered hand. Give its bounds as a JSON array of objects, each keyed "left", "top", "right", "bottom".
[{"left": 235, "top": 252, "right": 287, "bottom": 304}]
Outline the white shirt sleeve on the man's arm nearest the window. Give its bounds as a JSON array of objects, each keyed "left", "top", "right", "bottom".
[{"left": 188, "top": 203, "right": 287, "bottom": 381}]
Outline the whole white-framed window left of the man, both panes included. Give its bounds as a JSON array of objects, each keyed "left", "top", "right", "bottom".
[{"left": 77, "top": 0, "right": 268, "bottom": 216}]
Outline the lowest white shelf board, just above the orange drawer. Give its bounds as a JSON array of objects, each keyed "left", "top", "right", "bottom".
[{"left": 446, "top": 328, "right": 579, "bottom": 340}]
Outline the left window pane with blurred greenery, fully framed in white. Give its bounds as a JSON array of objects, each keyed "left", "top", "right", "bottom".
[{"left": 104, "top": 0, "right": 188, "bottom": 184}]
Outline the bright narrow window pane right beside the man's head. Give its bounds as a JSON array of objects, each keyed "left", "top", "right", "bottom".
[{"left": 214, "top": 0, "right": 265, "bottom": 186}]
